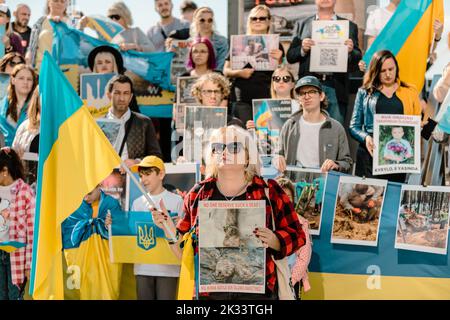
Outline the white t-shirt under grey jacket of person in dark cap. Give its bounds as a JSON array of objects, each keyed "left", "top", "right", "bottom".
[{"left": 297, "top": 116, "right": 325, "bottom": 168}]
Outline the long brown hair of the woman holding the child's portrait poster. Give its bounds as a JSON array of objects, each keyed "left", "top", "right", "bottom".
[{"left": 362, "top": 50, "right": 408, "bottom": 94}]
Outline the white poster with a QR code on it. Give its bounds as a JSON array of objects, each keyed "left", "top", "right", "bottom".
[{"left": 309, "top": 20, "right": 349, "bottom": 72}]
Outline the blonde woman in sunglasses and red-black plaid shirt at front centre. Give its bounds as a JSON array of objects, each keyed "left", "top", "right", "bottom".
[{"left": 152, "top": 126, "right": 305, "bottom": 299}]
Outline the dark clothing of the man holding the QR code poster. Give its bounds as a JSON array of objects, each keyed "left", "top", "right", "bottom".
[{"left": 286, "top": 15, "right": 362, "bottom": 104}]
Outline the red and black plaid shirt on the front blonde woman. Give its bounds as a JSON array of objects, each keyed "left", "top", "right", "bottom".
[{"left": 177, "top": 176, "right": 306, "bottom": 292}]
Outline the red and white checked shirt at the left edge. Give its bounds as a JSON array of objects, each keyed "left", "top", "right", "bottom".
[{"left": 9, "top": 179, "right": 35, "bottom": 286}]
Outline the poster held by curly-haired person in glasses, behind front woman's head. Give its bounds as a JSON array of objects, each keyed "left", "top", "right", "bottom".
[{"left": 183, "top": 106, "right": 227, "bottom": 163}]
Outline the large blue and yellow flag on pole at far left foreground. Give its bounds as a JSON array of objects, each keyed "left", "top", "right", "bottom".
[{"left": 30, "top": 52, "right": 120, "bottom": 299}]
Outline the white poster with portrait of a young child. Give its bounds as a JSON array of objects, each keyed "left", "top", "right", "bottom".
[{"left": 372, "top": 114, "right": 421, "bottom": 175}]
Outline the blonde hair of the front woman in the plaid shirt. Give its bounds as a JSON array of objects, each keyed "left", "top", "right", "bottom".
[{"left": 205, "top": 125, "right": 260, "bottom": 182}]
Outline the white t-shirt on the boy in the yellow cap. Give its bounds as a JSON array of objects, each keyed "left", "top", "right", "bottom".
[{"left": 131, "top": 190, "right": 183, "bottom": 277}]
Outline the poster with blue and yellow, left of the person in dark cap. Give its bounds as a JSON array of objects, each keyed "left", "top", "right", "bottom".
[{"left": 253, "top": 99, "right": 292, "bottom": 155}]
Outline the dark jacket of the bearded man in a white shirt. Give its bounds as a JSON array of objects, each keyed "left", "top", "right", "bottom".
[{"left": 125, "top": 112, "right": 162, "bottom": 159}]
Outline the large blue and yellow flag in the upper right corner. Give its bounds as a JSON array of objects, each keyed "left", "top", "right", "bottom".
[{"left": 363, "top": 0, "right": 444, "bottom": 91}]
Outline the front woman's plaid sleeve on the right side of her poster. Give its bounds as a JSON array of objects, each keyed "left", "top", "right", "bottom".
[{"left": 268, "top": 180, "right": 306, "bottom": 260}]
